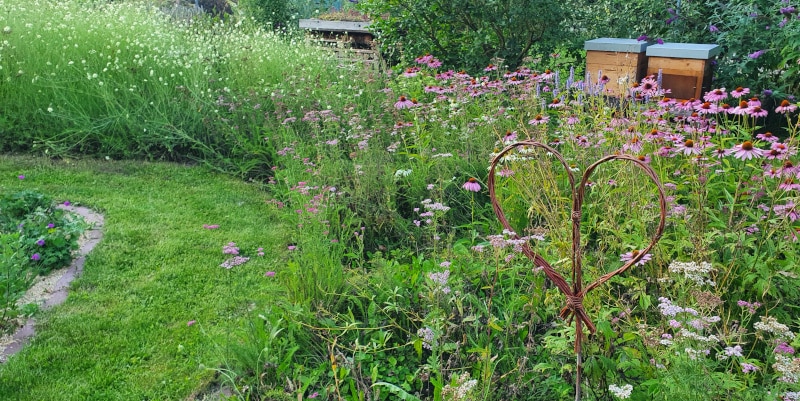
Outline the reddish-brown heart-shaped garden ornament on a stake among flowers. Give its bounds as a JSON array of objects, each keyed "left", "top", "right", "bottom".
[{"left": 487, "top": 140, "right": 667, "bottom": 401}]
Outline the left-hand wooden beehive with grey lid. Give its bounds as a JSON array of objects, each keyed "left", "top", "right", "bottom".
[{"left": 583, "top": 38, "right": 648, "bottom": 96}]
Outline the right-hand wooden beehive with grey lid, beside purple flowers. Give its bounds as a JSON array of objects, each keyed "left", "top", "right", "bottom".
[{"left": 647, "top": 43, "right": 722, "bottom": 100}]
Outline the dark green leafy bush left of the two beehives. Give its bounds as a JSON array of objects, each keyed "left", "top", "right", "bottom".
[{"left": 359, "top": 0, "right": 566, "bottom": 72}]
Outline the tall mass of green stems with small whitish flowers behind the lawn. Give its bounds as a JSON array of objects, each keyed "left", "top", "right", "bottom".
[{"left": 0, "top": 0, "right": 376, "bottom": 178}]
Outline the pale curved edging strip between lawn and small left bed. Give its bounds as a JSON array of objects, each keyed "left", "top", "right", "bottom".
[{"left": 0, "top": 205, "right": 105, "bottom": 363}]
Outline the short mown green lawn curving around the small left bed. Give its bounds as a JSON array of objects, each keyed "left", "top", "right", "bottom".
[{"left": 0, "top": 156, "right": 285, "bottom": 400}]
